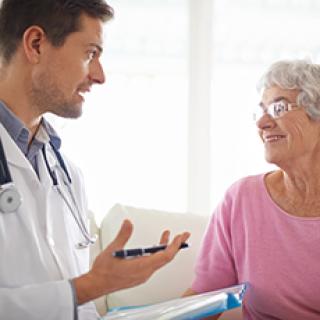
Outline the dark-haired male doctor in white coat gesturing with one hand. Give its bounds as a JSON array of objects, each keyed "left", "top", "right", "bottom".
[{"left": 0, "top": 0, "right": 189, "bottom": 320}]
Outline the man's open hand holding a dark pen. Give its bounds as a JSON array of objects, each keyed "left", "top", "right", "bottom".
[{"left": 73, "top": 220, "right": 190, "bottom": 305}]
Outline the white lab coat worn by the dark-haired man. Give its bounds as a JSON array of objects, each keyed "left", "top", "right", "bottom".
[{"left": 0, "top": 124, "right": 98, "bottom": 320}]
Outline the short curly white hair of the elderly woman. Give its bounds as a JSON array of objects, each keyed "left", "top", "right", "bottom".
[{"left": 257, "top": 60, "right": 320, "bottom": 120}]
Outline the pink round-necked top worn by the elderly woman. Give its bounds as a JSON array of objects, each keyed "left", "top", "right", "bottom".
[{"left": 192, "top": 175, "right": 320, "bottom": 320}]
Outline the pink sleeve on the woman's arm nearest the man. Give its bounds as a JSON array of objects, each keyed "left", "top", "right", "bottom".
[{"left": 192, "top": 191, "right": 237, "bottom": 293}]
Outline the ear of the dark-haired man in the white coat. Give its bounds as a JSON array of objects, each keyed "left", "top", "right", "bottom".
[{"left": 22, "top": 26, "right": 47, "bottom": 64}]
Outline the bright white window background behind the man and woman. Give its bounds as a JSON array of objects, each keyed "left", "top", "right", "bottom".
[{"left": 53, "top": 0, "right": 320, "bottom": 221}]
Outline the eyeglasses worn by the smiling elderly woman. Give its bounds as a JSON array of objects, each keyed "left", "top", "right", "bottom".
[{"left": 253, "top": 100, "right": 299, "bottom": 121}]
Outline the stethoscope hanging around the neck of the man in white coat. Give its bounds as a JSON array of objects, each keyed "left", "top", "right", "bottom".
[{"left": 0, "top": 139, "right": 97, "bottom": 249}]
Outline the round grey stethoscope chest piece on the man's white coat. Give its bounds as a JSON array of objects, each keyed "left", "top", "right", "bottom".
[{"left": 0, "top": 183, "right": 22, "bottom": 213}]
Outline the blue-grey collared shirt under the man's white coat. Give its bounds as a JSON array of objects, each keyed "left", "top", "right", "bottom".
[{"left": 0, "top": 101, "right": 61, "bottom": 176}]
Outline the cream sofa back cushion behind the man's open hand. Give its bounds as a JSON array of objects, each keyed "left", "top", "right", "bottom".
[{"left": 100, "top": 204, "right": 208, "bottom": 308}]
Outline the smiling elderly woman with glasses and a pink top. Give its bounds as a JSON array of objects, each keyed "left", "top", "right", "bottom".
[{"left": 185, "top": 60, "right": 320, "bottom": 320}]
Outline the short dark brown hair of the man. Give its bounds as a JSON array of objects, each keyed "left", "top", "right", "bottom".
[{"left": 0, "top": 0, "right": 113, "bottom": 63}]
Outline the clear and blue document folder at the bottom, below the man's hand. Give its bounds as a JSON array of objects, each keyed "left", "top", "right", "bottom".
[{"left": 101, "top": 284, "right": 247, "bottom": 320}]
